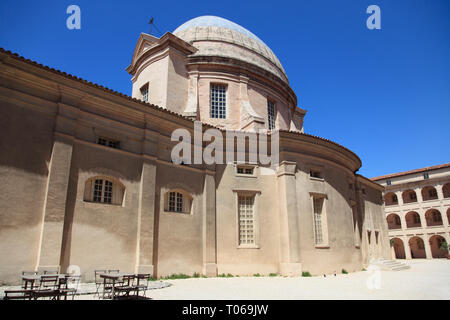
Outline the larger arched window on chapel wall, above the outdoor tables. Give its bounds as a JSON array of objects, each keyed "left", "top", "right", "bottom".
[{"left": 84, "top": 177, "right": 125, "bottom": 206}]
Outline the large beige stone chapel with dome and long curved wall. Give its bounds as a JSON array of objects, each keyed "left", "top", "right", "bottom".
[{"left": 0, "top": 16, "right": 390, "bottom": 283}]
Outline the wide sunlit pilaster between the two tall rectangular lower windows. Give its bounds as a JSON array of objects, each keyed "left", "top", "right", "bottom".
[{"left": 277, "top": 161, "right": 302, "bottom": 276}]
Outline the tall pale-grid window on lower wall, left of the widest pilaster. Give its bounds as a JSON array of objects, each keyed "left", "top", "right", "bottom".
[{"left": 238, "top": 195, "right": 255, "bottom": 245}]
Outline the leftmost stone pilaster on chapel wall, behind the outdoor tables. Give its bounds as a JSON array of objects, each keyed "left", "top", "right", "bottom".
[{"left": 36, "top": 132, "right": 73, "bottom": 271}]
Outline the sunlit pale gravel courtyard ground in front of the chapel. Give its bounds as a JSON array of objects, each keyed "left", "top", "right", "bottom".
[{"left": 76, "top": 259, "right": 450, "bottom": 300}]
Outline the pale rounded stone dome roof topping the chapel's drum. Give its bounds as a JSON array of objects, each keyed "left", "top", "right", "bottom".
[{"left": 173, "top": 16, "right": 289, "bottom": 83}]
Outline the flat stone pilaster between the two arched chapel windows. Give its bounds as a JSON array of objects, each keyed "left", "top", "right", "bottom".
[{"left": 136, "top": 157, "right": 156, "bottom": 275}]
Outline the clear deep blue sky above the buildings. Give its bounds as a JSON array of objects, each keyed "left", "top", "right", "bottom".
[{"left": 0, "top": 0, "right": 450, "bottom": 177}]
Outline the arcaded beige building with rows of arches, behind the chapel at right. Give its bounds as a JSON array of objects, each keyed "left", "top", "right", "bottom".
[{"left": 371, "top": 163, "right": 450, "bottom": 259}]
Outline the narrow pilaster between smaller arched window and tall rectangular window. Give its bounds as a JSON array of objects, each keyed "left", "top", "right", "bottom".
[{"left": 203, "top": 166, "right": 217, "bottom": 277}]
